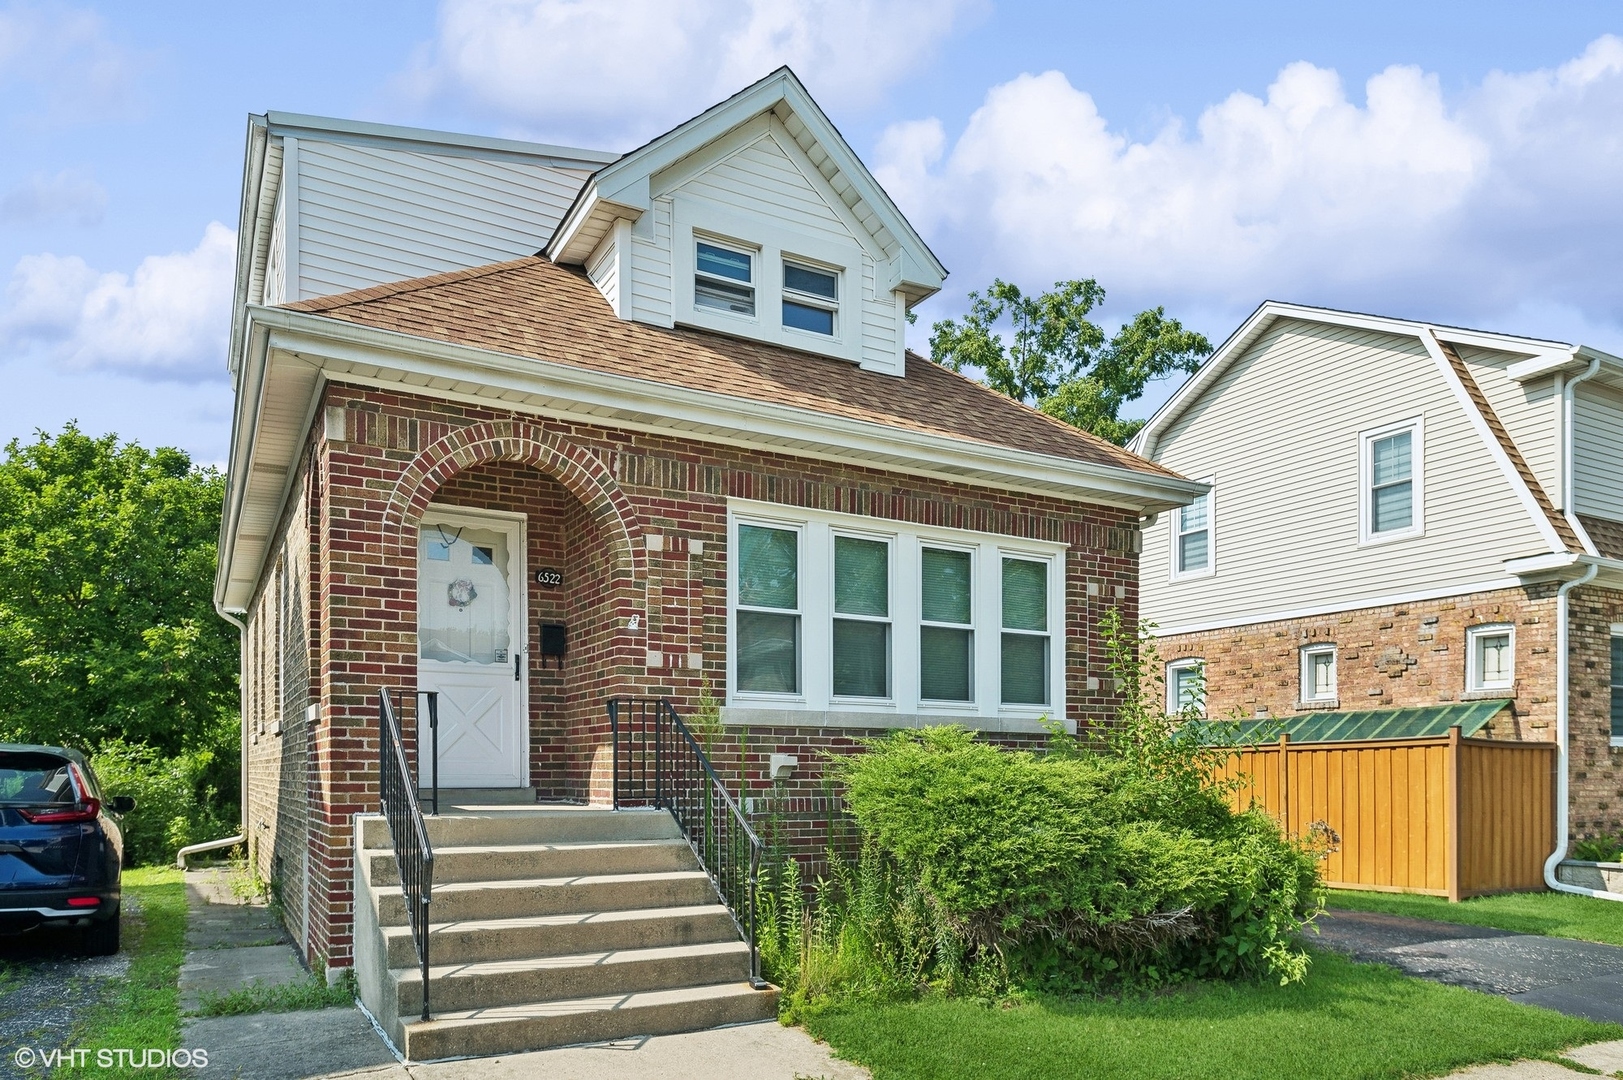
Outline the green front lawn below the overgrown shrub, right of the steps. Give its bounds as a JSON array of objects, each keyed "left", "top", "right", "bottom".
[{"left": 807, "top": 952, "right": 1623, "bottom": 1080}]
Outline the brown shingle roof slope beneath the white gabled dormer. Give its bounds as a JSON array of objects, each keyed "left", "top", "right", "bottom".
[{"left": 287, "top": 257, "right": 1177, "bottom": 476}]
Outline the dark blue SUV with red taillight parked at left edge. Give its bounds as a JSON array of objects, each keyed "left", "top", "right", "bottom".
[{"left": 0, "top": 742, "right": 135, "bottom": 957}]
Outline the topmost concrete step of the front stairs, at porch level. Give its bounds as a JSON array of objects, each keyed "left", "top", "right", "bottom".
[{"left": 355, "top": 806, "right": 682, "bottom": 851}]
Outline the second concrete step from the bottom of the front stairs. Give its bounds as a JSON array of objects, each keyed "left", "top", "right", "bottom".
[{"left": 390, "top": 939, "right": 750, "bottom": 1017}]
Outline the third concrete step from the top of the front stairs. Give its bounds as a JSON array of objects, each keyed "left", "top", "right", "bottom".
[{"left": 373, "top": 870, "right": 716, "bottom": 927}]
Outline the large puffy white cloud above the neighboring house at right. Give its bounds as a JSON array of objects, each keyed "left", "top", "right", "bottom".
[{"left": 876, "top": 36, "right": 1623, "bottom": 345}]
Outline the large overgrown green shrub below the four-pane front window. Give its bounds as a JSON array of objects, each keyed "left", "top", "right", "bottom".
[{"left": 763, "top": 617, "right": 1319, "bottom": 1012}]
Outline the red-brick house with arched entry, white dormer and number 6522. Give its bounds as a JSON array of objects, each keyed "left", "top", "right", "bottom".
[{"left": 216, "top": 70, "right": 1204, "bottom": 1031}]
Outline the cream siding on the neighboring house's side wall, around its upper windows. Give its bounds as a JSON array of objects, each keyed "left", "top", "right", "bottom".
[{"left": 1139, "top": 320, "right": 1548, "bottom": 633}]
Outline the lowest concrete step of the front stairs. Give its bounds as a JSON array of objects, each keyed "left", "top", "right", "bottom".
[{"left": 401, "top": 983, "right": 777, "bottom": 1061}]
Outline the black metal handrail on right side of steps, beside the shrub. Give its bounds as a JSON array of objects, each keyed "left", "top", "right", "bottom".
[{"left": 609, "top": 697, "right": 766, "bottom": 989}]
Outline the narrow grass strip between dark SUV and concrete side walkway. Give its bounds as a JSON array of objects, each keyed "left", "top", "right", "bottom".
[{"left": 50, "top": 867, "right": 187, "bottom": 1080}]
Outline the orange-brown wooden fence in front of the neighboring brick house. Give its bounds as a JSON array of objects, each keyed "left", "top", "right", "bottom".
[{"left": 1224, "top": 728, "right": 1556, "bottom": 900}]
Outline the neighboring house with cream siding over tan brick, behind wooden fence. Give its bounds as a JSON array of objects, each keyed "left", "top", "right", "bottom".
[{"left": 1131, "top": 302, "right": 1623, "bottom": 870}]
